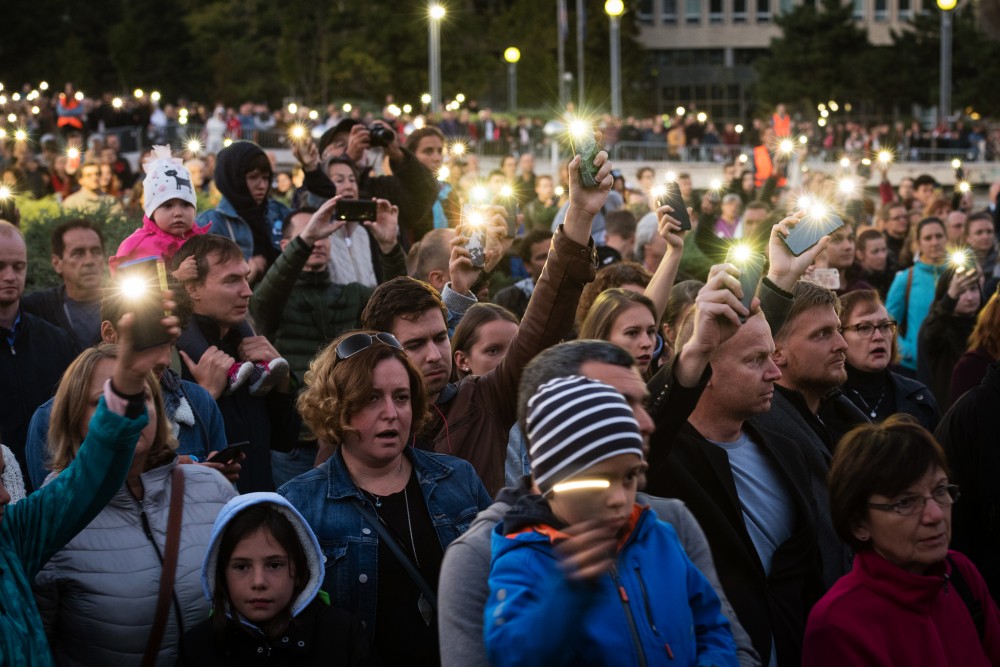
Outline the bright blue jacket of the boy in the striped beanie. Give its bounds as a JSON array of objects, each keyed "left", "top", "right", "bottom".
[{"left": 483, "top": 505, "right": 738, "bottom": 667}]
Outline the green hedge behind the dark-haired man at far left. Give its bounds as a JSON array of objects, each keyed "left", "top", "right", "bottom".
[{"left": 17, "top": 197, "right": 142, "bottom": 293}]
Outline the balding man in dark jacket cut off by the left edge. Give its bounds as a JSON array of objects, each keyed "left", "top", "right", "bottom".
[{"left": 0, "top": 220, "right": 76, "bottom": 491}]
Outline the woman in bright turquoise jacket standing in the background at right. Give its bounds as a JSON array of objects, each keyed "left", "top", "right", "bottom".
[{"left": 885, "top": 218, "right": 947, "bottom": 376}]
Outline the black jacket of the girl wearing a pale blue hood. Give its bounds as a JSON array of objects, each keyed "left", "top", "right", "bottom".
[{"left": 178, "top": 597, "right": 378, "bottom": 667}]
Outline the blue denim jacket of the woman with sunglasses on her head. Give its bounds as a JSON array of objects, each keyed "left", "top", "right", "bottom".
[{"left": 278, "top": 447, "right": 492, "bottom": 633}]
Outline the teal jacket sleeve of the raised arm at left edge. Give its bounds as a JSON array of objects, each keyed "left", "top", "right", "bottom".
[{"left": 0, "top": 398, "right": 149, "bottom": 667}]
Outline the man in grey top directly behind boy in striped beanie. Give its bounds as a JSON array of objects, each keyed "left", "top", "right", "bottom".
[{"left": 438, "top": 340, "right": 761, "bottom": 667}]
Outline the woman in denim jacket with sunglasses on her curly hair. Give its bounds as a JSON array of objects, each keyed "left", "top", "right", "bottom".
[{"left": 278, "top": 331, "right": 491, "bottom": 666}]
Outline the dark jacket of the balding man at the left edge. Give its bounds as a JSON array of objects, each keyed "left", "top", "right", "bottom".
[{"left": 0, "top": 310, "right": 76, "bottom": 491}]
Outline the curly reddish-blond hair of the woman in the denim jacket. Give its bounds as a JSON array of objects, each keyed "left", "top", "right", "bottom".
[{"left": 296, "top": 330, "right": 429, "bottom": 444}]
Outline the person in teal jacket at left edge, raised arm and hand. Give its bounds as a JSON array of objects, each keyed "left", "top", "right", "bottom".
[{"left": 0, "top": 302, "right": 180, "bottom": 666}]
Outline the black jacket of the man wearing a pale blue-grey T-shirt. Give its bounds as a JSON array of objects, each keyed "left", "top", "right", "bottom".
[{"left": 646, "top": 423, "right": 823, "bottom": 667}]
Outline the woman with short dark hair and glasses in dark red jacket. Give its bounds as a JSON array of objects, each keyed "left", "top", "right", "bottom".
[{"left": 802, "top": 417, "right": 1000, "bottom": 667}]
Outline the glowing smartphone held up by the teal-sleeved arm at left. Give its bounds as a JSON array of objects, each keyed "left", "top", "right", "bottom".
[{"left": 116, "top": 257, "right": 172, "bottom": 350}]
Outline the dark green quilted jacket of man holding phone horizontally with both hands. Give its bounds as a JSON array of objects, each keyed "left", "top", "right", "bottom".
[{"left": 250, "top": 237, "right": 406, "bottom": 380}]
